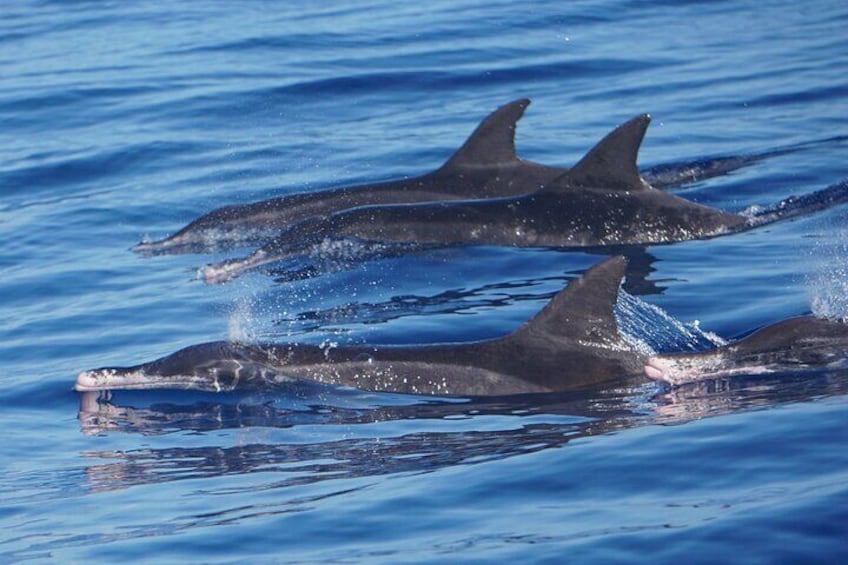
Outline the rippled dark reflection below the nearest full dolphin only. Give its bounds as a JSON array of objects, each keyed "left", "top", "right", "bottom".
[{"left": 79, "top": 389, "right": 649, "bottom": 490}]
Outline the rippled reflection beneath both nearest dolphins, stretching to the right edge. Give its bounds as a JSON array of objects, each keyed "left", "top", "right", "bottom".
[{"left": 79, "top": 372, "right": 848, "bottom": 490}]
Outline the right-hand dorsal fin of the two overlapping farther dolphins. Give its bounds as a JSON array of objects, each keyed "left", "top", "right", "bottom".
[{"left": 543, "top": 114, "right": 651, "bottom": 194}]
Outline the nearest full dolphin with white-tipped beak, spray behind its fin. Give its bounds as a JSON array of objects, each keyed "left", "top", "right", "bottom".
[{"left": 75, "top": 257, "right": 645, "bottom": 396}]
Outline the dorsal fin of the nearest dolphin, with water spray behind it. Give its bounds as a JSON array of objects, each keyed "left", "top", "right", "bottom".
[{"left": 508, "top": 256, "right": 627, "bottom": 344}]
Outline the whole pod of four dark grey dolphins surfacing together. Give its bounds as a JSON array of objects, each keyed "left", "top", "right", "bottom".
[{"left": 75, "top": 100, "right": 848, "bottom": 397}]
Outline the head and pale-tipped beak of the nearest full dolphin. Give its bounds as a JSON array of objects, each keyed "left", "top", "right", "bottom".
[{"left": 74, "top": 341, "right": 278, "bottom": 392}]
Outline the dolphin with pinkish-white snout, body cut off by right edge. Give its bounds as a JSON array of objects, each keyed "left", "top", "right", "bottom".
[{"left": 645, "top": 316, "right": 848, "bottom": 385}]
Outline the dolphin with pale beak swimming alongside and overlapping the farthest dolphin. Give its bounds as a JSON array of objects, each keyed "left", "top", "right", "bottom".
[{"left": 203, "top": 114, "right": 848, "bottom": 283}]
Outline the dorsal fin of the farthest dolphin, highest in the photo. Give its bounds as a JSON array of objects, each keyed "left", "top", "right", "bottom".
[{"left": 442, "top": 98, "right": 530, "bottom": 169}]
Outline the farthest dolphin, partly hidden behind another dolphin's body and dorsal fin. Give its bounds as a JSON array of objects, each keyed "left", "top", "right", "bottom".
[{"left": 133, "top": 98, "right": 768, "bottom": 254}]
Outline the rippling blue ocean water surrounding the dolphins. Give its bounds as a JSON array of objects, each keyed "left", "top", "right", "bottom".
[{"left": 0, "top": 0, "right": 848, "bottom": 563}]
